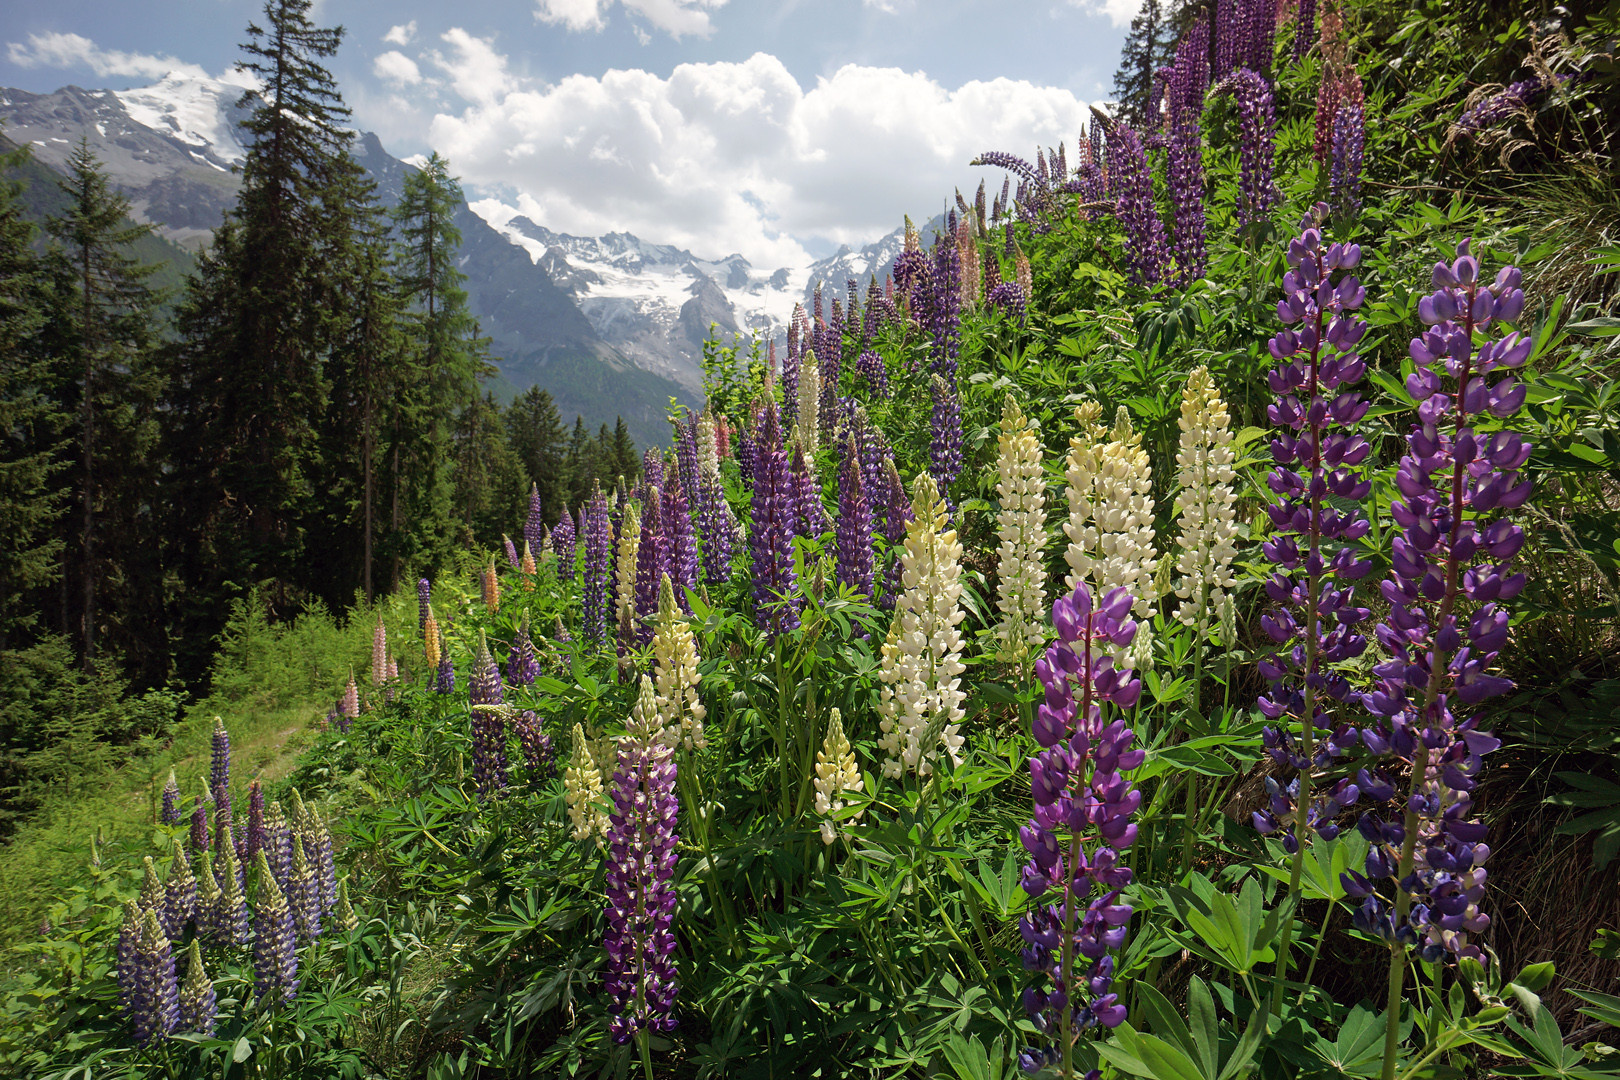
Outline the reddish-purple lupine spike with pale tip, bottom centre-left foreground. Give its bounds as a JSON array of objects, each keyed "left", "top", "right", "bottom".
[{"left": 603, "top": 725, "right": 680, "bottom": 1044}]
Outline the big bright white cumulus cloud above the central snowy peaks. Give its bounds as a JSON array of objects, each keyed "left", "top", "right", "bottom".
[{"left": 405, "top": 46, "right": 1087, "bottom": 266}]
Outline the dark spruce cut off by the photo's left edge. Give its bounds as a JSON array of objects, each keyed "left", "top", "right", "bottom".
[{"left": 0, "top": 140, "right": 66, "bottom": 654}]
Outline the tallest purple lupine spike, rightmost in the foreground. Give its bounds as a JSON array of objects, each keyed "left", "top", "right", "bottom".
[{"left": 1345, "top": 240, "right": 1533, "bottom": 965}]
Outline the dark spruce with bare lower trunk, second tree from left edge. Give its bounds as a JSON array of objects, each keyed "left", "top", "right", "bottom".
[{"left": 45, "top": 139, "right": 162, "bottom": 672}]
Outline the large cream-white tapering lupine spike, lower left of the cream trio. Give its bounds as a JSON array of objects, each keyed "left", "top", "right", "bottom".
[{"left": 878, "top": 473, "right": 967, "bottom": 779}]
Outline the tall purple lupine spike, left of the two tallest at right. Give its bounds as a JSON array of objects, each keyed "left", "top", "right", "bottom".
[{"left": 1256, "top": 202, "right": 1372, "bottom": 853}]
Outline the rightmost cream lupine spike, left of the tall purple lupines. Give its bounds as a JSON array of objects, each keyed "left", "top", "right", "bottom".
[{"left": 1176, "top": 368, "right": 1238, "bottom": 633}]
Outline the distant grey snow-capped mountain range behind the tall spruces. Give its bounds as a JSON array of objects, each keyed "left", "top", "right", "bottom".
[{"left": 0, "top": 73, "right": 927, "bottom": 444}]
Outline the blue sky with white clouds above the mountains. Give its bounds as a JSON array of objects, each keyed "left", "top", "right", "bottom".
[{"left": 0, "top": 0, "right": 1136, "bottom": 266}]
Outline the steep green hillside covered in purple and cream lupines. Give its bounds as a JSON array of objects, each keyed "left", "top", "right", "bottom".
[{"left": 0, "top": 0, "right": 1620, "bottom": 1080}]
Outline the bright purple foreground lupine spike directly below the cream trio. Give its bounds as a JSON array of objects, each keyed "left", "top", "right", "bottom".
[{"left": 1019, "top": 583, "right": 1145, "bottom": 1067}]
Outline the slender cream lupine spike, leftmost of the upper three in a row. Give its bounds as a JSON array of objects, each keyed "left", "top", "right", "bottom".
[{"left": 996, "top": 395, "right": 1047, "bottom": 661}]
